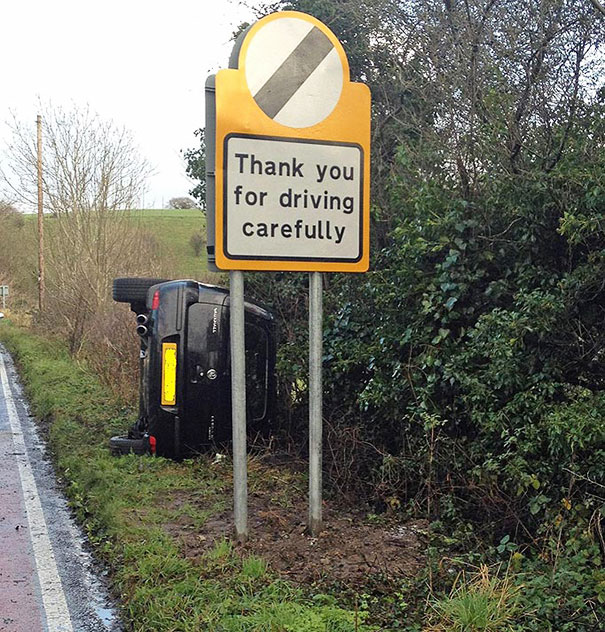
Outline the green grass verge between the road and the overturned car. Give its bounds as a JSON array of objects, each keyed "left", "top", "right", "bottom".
[{"left": 0, "top": 320, "right": 371, "bottom": 632}]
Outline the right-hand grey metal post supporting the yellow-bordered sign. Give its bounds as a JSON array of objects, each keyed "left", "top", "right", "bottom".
[{"left": 309, "top": 272, "right": 323, "bottom": 536}]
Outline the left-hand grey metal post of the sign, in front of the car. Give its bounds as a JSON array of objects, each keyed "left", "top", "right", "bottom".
[{"left": 229, "top": 270, "right": 248, "bottom": 542}]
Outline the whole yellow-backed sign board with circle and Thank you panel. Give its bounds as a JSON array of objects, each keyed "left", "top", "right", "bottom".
[{"left": 215, "top": 11, "right": 370, "bottom": 272}]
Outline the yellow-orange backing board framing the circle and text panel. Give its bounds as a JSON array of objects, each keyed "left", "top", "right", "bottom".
[{"left": 215, "top": 11, "right": 371, "bottom": 272}]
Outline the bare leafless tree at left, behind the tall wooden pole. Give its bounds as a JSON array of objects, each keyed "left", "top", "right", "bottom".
[{"left": 2, "top": 103, "right": 154, "bottom": 353}]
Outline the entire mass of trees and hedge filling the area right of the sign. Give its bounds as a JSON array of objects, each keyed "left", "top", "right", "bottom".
[{"left": 184, "top": 0, "right": 605, "bottom": 631}]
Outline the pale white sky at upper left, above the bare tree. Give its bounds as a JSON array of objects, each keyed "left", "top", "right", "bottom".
[{"left": 0, "top": 0, "right": 258, "bottom": 208}]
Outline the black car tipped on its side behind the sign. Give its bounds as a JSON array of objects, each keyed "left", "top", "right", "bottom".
[{"left": 110, "top": 278, "right": 275, "bottom": 459}]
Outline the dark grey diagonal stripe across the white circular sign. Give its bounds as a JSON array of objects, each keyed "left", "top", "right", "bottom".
[{"left": 254, "top": 26, "right": 334, "bottom": 118}]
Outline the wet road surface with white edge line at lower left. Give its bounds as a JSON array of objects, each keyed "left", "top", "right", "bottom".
[{"left": 0, "top": 346, "right": 122, "bottom": 632}]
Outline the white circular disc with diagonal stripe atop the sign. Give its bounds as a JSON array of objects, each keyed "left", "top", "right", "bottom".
[{"left": 244, "top": 17, "right": 344, "bottom": 128}]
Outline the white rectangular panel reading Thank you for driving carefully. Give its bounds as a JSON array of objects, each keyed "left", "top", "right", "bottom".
[{"left": 223, "top": 134, "right": 364, "bottom": 263}]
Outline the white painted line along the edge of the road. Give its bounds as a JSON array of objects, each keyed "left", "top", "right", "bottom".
[{"left": 0, "top": 355, "right": 73, "bottom": 632}]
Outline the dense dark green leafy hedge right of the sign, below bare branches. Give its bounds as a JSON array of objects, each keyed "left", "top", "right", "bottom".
[{"left": 247, "top": 105, "right": 605, "bottom": 540}]
